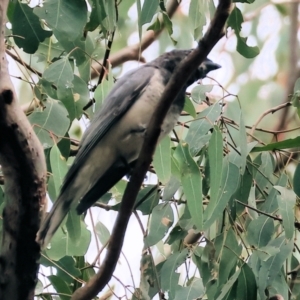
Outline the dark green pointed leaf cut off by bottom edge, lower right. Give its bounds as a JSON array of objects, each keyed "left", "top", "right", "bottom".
[{"left": 236, "top": 264, "right": 257, "bottom": 300}]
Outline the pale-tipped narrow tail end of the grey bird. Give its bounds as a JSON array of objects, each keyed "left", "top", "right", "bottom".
[{"left": 36, "top": 194, "right": 72, "bottom": 249}]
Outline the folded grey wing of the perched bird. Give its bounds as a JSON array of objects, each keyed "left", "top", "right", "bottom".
[{"left": 61, "top": 65, "right": 155, "bottom": 193}]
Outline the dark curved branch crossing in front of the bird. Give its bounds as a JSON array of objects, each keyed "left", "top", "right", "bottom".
[{"left": 72, "top": 0, "right": 231, "bottom": 300}]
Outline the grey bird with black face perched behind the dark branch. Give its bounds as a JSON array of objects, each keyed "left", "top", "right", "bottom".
[{"left": 37, "top": 49, "right": 221, "bottom": 248}]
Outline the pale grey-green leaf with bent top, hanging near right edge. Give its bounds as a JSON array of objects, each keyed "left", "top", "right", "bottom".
[{"left": 274, "top": 186, "right": 296, "bottom": 239}]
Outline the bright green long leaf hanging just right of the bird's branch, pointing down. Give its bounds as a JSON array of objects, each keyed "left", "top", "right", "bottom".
[{"left": 174, "top": 144, "right": 203, "bottom": 230}]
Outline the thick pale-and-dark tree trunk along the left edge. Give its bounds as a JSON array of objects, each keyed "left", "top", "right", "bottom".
[{"left": 0, "top": 0, "right": 46, "bottom": 300}]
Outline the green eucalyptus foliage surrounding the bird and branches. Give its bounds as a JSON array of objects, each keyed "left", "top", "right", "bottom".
[{"left": 0, "top": 0, "right": 300, "bottom": 300}]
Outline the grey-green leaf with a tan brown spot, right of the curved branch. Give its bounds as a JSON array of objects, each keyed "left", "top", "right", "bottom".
[{"left": 145, "top": 203, "right": 174, "bottom": 247}]
